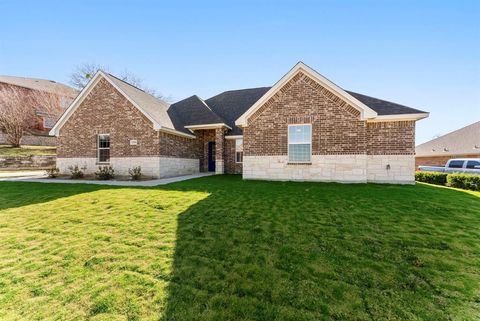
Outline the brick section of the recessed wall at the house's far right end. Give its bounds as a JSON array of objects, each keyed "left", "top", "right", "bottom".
[{"left": 367, "top": 121, "right": 415, "bottom": 155}]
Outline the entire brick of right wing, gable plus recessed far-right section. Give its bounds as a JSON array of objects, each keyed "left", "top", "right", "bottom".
[{"left": 244, "top": 73, "right": 415, "bottom": 156}]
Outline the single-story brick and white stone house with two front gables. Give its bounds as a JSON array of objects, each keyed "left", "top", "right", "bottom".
[{"left": 51, "top": 62, "right": 428, "bottom": 183}]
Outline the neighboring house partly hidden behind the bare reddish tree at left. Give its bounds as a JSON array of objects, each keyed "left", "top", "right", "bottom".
[{"left": 0, "top": 76, "right": 78, "bottom": 145}]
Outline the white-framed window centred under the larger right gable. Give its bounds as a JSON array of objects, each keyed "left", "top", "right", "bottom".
[{"left": 288, "top": 124, "right": 312, "bottom": 163}]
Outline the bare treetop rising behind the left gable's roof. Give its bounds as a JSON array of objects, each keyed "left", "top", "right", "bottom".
[{"left": 66, "top": 63, "right": 168, "bottom": 101}]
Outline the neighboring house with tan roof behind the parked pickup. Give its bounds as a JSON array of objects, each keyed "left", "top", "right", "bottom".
[{"left": 415, "top": 121, "right": 480, "bottom": 167}]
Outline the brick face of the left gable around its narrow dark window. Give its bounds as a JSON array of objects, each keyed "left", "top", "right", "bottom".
[{"left": 57, "top": 79, "right": 160, "bottom": 157}]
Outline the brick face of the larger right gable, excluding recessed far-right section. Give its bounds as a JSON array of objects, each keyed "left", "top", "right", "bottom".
[{"left": 244, "top": 73, "right": 367, "bottom": 156}]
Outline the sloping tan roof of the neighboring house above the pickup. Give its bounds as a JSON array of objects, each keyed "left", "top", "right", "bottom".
[{"left": 415, "top": 121, "right": 480, "bottom": 156}]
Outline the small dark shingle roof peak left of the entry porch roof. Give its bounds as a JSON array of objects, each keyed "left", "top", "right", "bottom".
[{"left": 168, "top": 95, "right": 225, "bottom": 133}]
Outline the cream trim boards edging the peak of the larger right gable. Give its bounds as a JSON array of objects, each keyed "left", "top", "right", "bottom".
[{"left": 235, "top": 62, "right": 377, "bottom": 126}]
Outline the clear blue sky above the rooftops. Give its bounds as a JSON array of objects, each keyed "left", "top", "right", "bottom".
[{"left": 0, "top": 0, "right": 480, "bottom": 144}]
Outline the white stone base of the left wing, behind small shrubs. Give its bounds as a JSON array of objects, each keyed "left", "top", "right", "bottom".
[{"left": 57, "top": 157, "right": 200, "bottom": 178}]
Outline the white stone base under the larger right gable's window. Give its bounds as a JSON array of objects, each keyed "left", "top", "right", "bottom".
[{"left": 243, "top": 155, "right": 367, "bottom": 183}]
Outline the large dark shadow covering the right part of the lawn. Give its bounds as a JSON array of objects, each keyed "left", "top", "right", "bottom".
[{"left": 161, "top": 176, "right": 480, "bottom": 321}]
